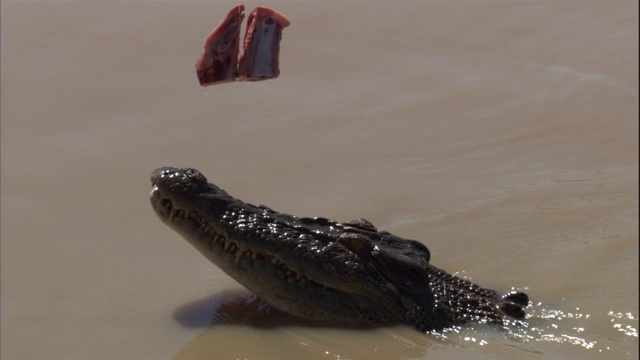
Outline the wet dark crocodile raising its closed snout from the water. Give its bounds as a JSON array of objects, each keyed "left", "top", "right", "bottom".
[{"left": 150, "top": 167, "right": 529, "bottom": 332}]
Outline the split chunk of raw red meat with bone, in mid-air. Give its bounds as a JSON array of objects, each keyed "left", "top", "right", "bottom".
[{"left": 196, "top": 5, "right": 290, "bottom": 86}]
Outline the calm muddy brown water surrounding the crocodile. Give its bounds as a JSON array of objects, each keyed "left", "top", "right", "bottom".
[{"left": 1, "top": 1, "right": 639, "bottom": 359}]
